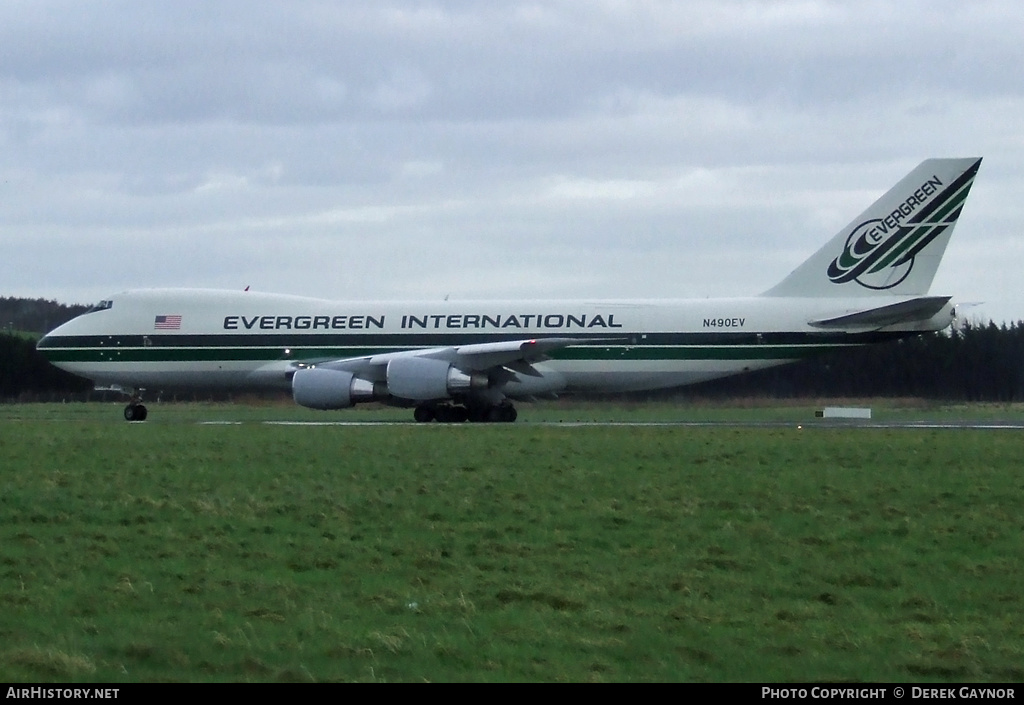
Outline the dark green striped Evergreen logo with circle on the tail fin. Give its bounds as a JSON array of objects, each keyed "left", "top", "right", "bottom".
[{"left": 827, "top": 164, "right": 978, "bottom": 290}]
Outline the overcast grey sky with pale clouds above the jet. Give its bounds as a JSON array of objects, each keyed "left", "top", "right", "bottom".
[{"left": 0, "top": 0, "right": 1024, "bottom": 321}]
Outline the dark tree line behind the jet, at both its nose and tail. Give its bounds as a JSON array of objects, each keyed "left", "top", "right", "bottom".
[{"left": 0, "top": 298, "right": 1024, "bottom": 402}]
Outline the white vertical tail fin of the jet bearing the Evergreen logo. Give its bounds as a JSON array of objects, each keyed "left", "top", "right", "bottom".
[{"left": 764, "top": 158, "right": 981, "bottom": 297}]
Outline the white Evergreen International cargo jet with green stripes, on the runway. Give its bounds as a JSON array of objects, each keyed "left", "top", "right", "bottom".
[{"left": 38, "top": 158, "right": 981, "bottom": 422}]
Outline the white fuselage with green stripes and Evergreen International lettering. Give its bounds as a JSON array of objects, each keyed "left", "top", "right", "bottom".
[{"left": 39, "top": 289, "right": 950, "bottom": 391}]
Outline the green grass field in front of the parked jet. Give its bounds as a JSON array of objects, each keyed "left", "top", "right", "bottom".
[{"left": 0, "top": 404, "right": 1024, "bottom": 681}]
